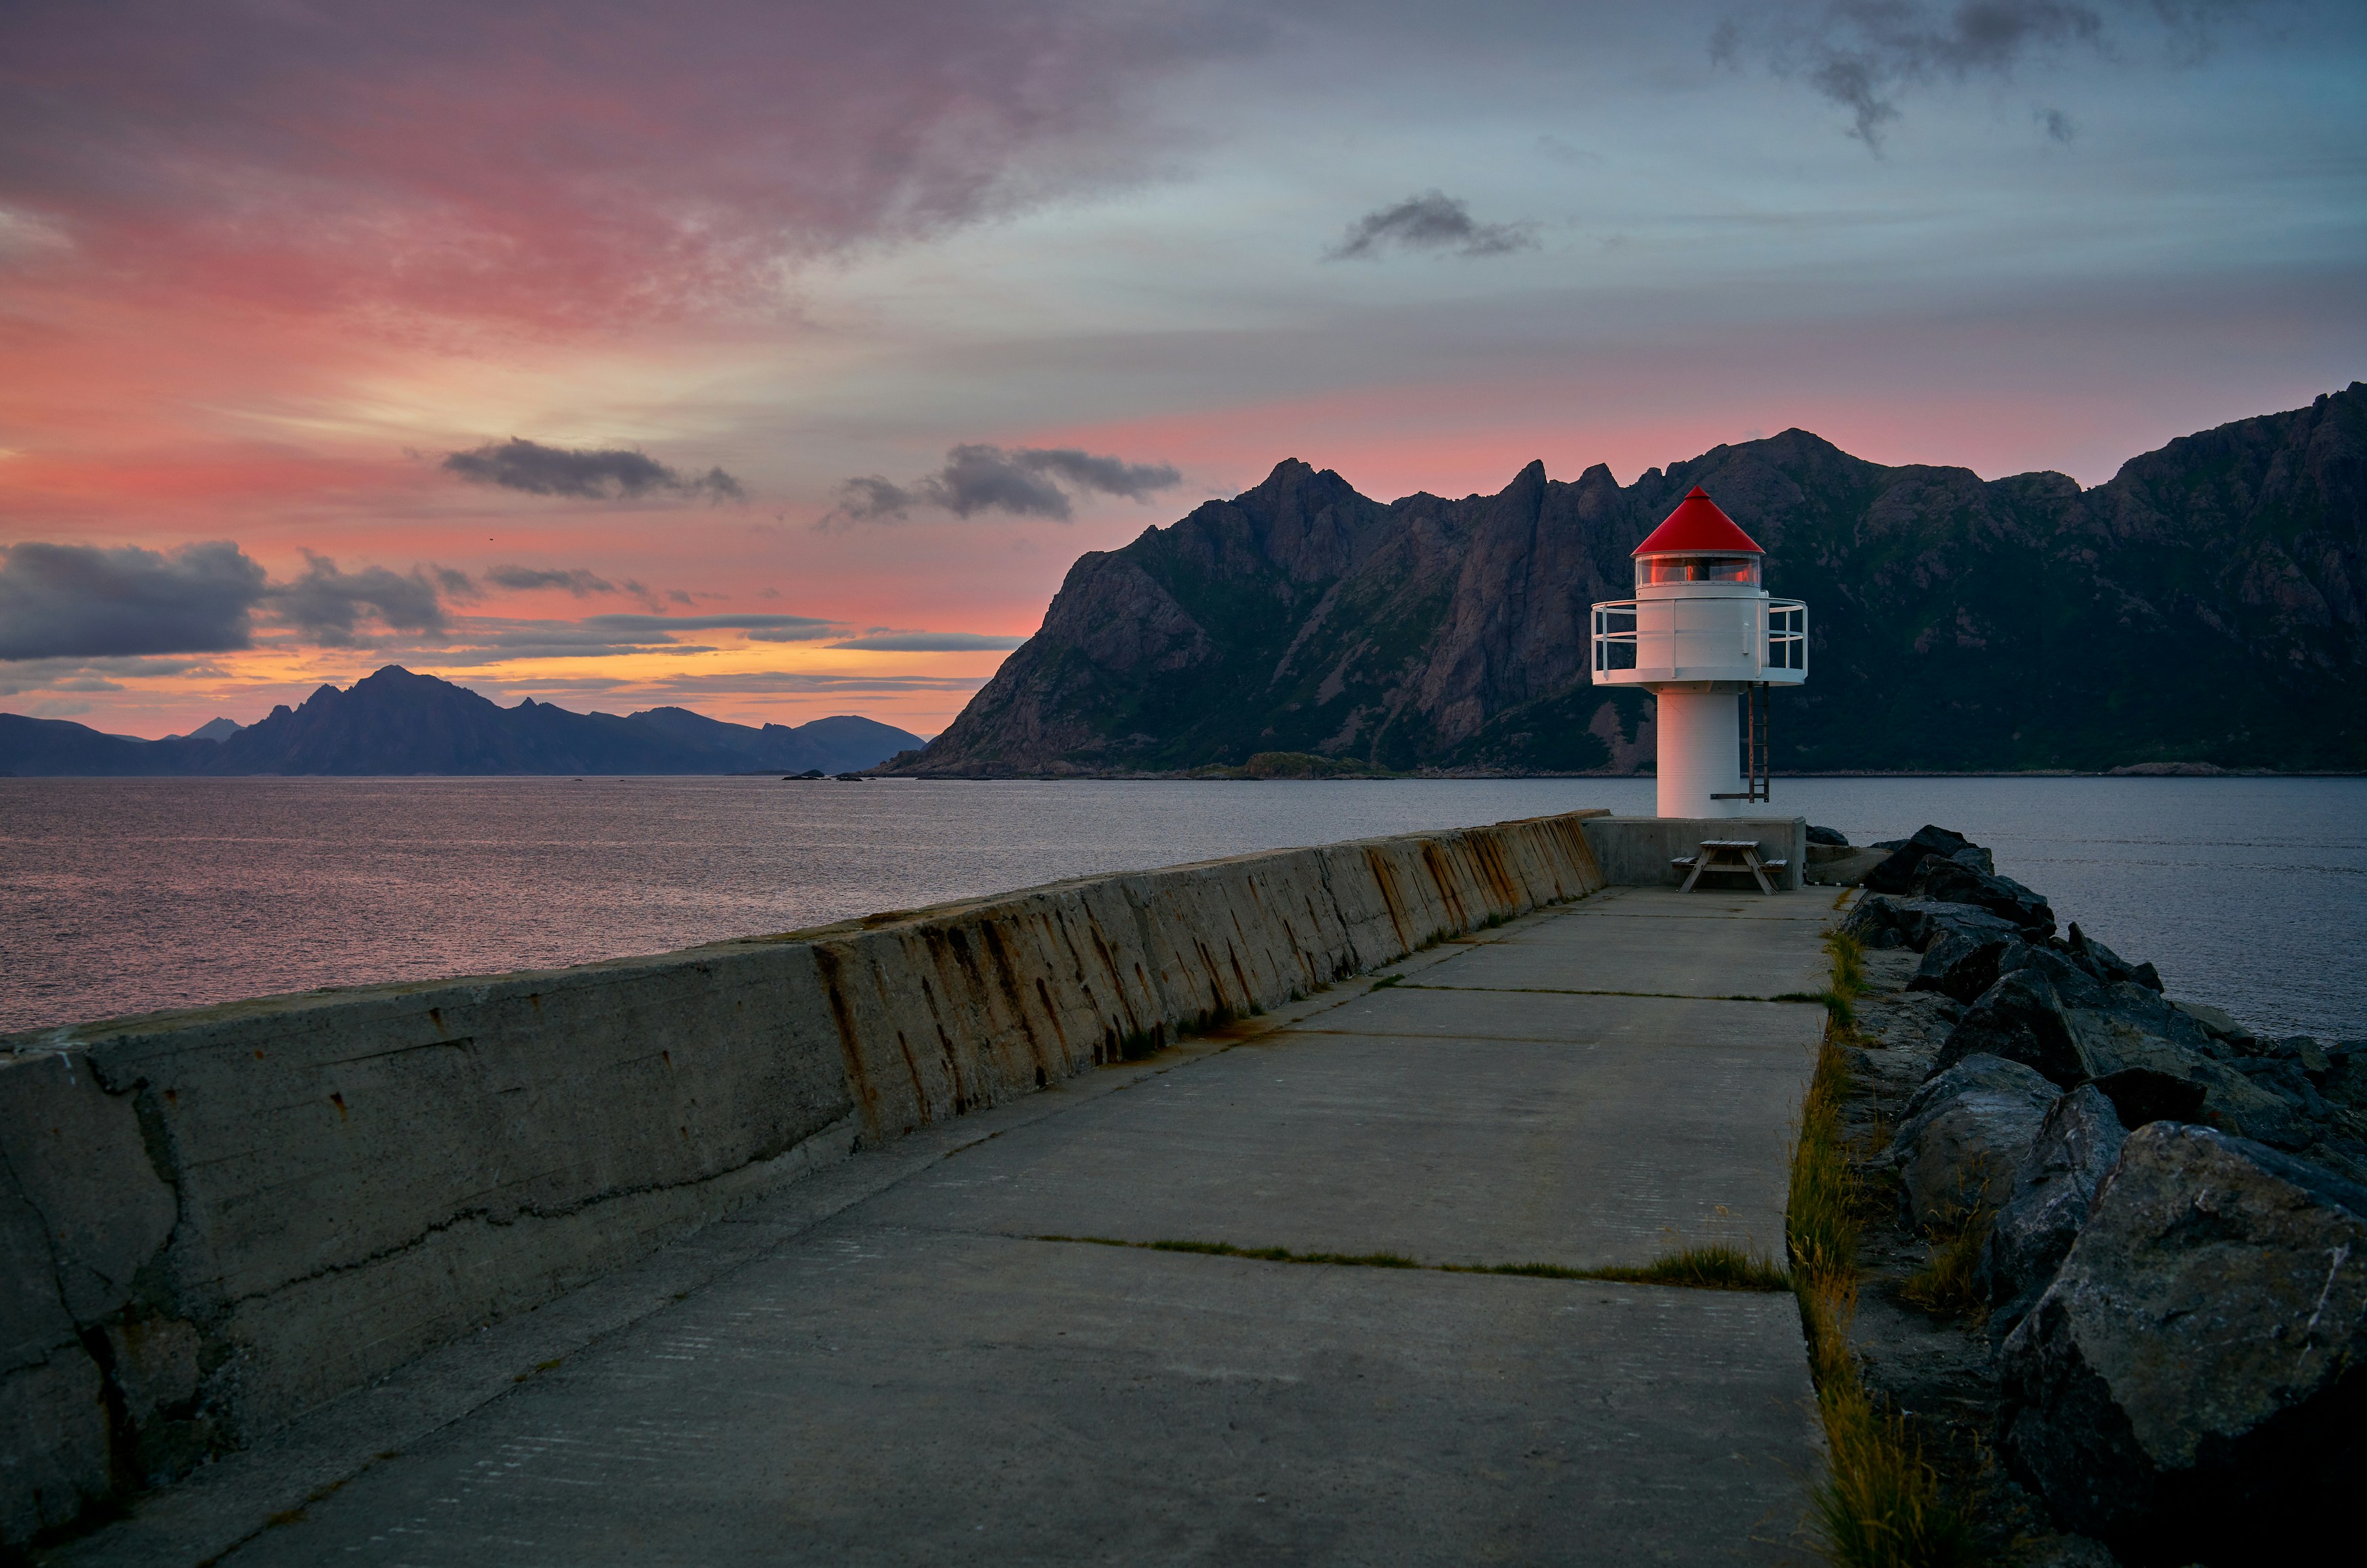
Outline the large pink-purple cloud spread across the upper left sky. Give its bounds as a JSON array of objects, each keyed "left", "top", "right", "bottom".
[{"left": 0, "top": 0, "right": 1236, "bottom": 329}]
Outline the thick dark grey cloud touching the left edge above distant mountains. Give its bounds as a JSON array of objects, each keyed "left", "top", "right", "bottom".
[{"left": 0, "top": 539, "right": 268, "bottom": 660}]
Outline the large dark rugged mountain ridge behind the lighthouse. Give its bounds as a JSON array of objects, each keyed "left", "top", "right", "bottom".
[{"left": 897, "top": 383, "right": 2367, "bottom": 776}]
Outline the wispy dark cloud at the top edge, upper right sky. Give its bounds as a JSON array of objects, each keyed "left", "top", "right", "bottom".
[{"left": 1709, "top": 0, "right": 2258, "bottom": 151}]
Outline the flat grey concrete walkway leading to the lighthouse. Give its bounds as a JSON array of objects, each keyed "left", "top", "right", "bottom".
[{"left": 55, "top": 889, "right": 1830, "bottom": 1568}]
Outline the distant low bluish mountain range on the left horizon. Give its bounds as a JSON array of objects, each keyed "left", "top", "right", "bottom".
[{"left": 0, "top": 665, "right": 921, "bottom": 776}]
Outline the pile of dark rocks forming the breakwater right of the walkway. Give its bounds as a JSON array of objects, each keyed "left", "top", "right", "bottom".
[{"left": 1844, "top": 828, "right": 2367, "bottom": 1563}]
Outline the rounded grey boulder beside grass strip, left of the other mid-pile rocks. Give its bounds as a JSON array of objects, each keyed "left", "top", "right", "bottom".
[{"left": 1892, "top": 1057, "right": 2057, "bottom": 1230}]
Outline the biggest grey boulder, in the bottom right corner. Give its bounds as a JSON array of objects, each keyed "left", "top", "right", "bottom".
[{"left": 1998, "top": 1121, "right": 2367, "bottom": 1566}]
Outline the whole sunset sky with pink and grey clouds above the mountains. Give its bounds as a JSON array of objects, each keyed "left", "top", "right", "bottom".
[{"left": 0, "top": 0, "right": 2367, "bottom": 736}]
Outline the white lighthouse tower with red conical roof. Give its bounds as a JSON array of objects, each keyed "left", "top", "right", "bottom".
[{"left": 1595, "top": 485, "right": 1808, "bottom": 816}]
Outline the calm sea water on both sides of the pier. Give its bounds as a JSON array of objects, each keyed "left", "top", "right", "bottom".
[{"left": 0, "top": 778, "right": 2367, "bottom": 1039}]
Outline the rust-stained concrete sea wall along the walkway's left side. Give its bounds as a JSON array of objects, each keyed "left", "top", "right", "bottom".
[{"left": 0, "top": 811, "right": 1610, "bottom": 1544}]
